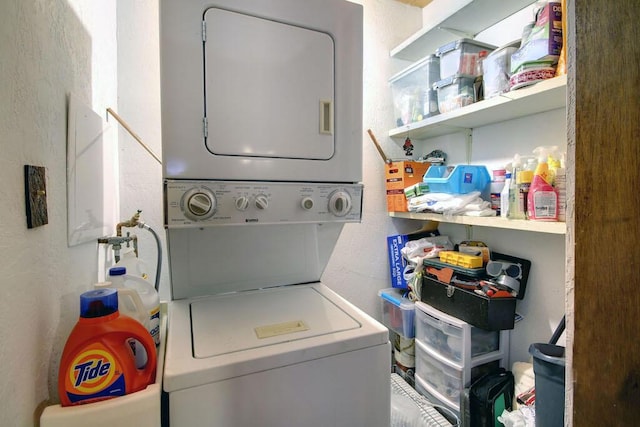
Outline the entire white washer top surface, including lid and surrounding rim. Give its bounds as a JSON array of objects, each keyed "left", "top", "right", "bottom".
[{"left": 162, "top": 283, "right": 389, "bottom": 392}]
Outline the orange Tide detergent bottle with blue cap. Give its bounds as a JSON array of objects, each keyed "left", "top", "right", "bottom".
[{"left": 58, "top": 289, "right": 157, "bottom": 406}]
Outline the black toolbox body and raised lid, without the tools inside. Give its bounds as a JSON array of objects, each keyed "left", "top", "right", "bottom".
[{"left": 420, "top": 252, "right": 531, "bottom": 331}]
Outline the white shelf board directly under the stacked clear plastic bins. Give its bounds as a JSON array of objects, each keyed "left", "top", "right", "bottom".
[{"left": 389, "top": 75, "right": 567, "bottom": 140}]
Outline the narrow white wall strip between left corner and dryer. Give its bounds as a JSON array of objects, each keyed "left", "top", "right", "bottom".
[{"left": 115, "top": 0, "right": 170, "bottom": 301}]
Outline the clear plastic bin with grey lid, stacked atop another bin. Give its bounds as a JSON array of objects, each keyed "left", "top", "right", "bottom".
[{"left": 436, "top": 39, "right": 496, "bottom": 79}]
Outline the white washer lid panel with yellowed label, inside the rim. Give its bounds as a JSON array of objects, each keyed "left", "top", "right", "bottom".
[{"left": 190, "top": 286, "right": 361, "bottom": 359}]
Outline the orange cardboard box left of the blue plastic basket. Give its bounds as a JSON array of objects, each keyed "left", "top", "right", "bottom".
[{"left": 385, "top": 160, "right": 431, "bottom": 212}]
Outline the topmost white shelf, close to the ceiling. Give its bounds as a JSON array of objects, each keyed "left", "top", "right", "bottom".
[{"left": 390, "top": 0, "right": 535, "bottom": 61}]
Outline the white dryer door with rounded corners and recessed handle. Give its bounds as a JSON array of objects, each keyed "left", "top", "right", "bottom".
[{"left": 203, "top": 7, "right": 335, "bottom": 160}]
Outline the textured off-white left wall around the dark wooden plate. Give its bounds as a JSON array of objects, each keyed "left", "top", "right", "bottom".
[{"left": 0, "top": 0, "right": 117, "bottom": 426}]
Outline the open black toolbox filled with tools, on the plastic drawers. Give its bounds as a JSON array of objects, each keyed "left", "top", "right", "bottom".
[{"left": 420, "top": 252, "right": 531, "bottom": 331}]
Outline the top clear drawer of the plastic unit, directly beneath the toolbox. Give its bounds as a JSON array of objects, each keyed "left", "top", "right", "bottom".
[{"left": 416, "top": 303, "right": 500, "bottom": 366}]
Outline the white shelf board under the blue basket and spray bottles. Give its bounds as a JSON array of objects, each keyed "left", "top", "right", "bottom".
[{"left": 389, "top": 212, "right": 567, "bottom": 234}]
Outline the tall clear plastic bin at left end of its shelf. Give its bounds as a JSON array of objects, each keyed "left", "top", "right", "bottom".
[{"left": 389, "top": 55, "right": 440, "bottom": 126}]
